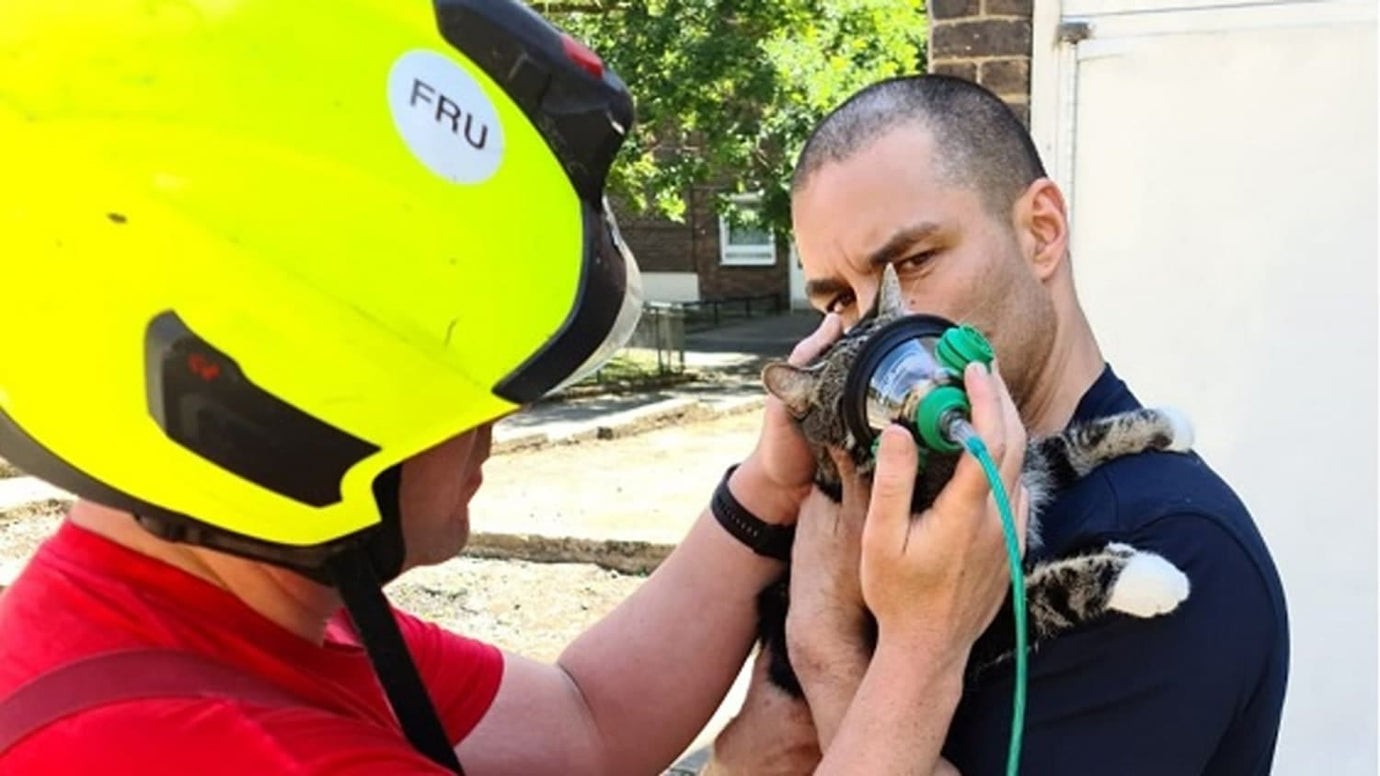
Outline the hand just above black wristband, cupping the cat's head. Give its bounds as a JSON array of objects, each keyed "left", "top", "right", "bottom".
[{"left": 729, "top": 313, "right": 843, "bottom": 523}]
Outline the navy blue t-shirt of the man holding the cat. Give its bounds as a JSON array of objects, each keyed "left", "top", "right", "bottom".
[{"left": 944, "top": 366, "right": 1289, "bottom": 776}]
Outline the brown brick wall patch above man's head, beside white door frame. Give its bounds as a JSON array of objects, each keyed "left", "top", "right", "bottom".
[{"left": 929, "top": 0, "right": 1032, "bottom": 127}]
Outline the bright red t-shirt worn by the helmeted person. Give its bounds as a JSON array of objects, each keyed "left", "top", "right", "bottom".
[{"left": 0, "top": 521, "right": 504, "bottom": 776}]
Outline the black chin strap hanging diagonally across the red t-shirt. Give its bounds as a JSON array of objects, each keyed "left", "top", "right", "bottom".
[{"left": 328, "top": 548, "right": 465, "bottom": 775}]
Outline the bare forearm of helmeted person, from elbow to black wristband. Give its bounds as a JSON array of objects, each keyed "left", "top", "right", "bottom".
[{"left": 558, "top": 512, "right": 784, "bottom": 773}]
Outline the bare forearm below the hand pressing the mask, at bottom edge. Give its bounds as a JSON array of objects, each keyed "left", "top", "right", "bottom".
[{"left": 816, "top": 645, "right": 963, "bottom": 776}]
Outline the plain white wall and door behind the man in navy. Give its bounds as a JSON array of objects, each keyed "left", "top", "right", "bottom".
[{"left": 1032, "top": 0, "right": 1377, "bottom": 776}]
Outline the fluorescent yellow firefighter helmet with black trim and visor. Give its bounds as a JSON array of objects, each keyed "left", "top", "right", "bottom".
[{"left": 0, "top": 0, "right": 640, "bottom": 577}]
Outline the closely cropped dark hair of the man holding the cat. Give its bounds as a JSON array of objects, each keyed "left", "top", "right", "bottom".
[{"left": 791, "top": 75, "right": 1045, "bottom": 217}]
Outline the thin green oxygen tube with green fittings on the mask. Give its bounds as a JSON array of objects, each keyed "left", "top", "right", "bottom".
[{"left": 915, "top": 326, "right": 1027, "bottom": 776}]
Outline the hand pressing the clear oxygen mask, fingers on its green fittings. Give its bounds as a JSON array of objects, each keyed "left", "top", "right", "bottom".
[{"left": 860, "top": 363, "right": 1029, "bottom": 663}]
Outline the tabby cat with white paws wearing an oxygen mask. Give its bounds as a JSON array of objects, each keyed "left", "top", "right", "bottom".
[{"left": 758, "top": 266, "right": 1192, "bottom": 697}]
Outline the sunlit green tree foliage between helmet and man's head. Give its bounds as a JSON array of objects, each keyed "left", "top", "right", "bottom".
[{"left": 534, "top": 0, "right": 926, "bottom": 235}]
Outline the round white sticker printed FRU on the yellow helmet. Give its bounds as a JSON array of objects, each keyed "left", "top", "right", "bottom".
[{"left": 388, "top": 50, "right": 504, "bottom": 184}]
